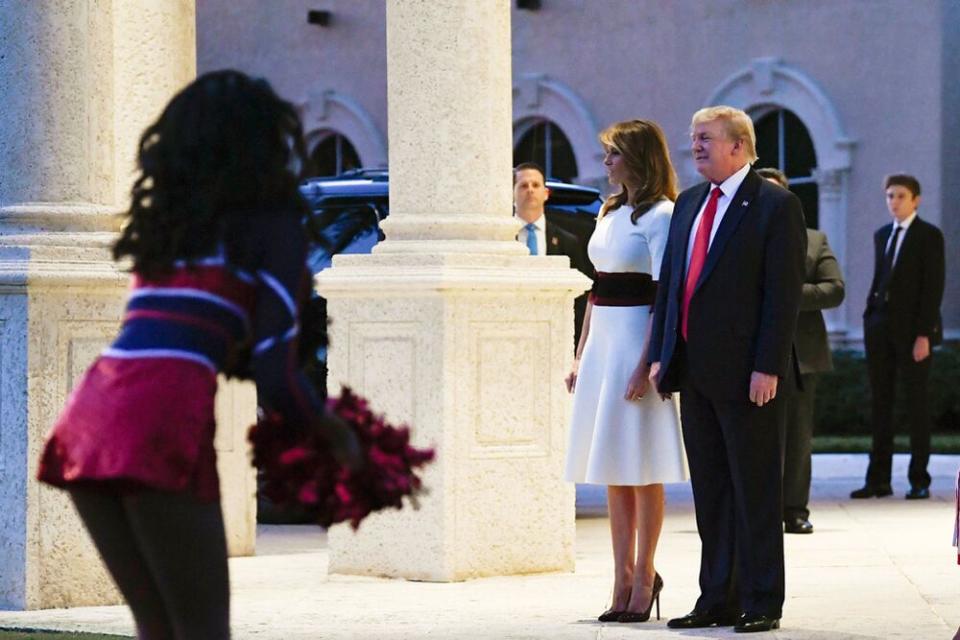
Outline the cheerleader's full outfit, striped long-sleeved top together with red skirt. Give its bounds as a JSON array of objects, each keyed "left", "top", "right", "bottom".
[{"left": 38, "top": 210, "right": 324, "bottom": 501}]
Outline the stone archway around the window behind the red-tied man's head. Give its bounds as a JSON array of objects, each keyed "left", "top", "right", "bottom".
[{"left": 685, "top": 58, "right": 856, "bottom": 335}]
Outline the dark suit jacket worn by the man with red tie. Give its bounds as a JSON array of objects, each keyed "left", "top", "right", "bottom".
[{"left": 649, "top": 170, "right": 807, "bottom": 402}]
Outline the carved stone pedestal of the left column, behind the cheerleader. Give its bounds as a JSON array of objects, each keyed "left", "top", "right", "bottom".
[{"left": 0, "top": 244, "right": 256, "bottom": 609}]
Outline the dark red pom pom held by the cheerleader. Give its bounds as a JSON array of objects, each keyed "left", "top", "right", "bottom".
[{"left": 248, "top": 387, "right": 434, "bottom": 529}]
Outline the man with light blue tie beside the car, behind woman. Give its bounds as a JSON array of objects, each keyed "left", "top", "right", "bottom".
[{"left": 513, "top": 162, "right": 593, "bottom": 345}]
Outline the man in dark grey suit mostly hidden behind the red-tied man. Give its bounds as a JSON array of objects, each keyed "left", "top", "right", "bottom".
[{"left": 757, "top": 168, "right": 844, "bottom": 533}]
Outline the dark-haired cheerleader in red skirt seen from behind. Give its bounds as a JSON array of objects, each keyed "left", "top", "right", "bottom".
[{"left": 39, "top": 71, "right": 357, "bottom": 640}]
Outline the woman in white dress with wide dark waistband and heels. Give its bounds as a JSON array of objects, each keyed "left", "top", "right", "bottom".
[{"left": 566, "top": 120, "right": 689, "bottom": 622}]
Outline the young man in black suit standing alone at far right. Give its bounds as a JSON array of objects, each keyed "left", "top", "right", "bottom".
[{"left": 850, "top": 174, "right": 945, "bottom": 500}]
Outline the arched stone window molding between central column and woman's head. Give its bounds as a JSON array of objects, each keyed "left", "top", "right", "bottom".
[{"left": 513, "top": 73, "right": 605, "bottom": 183}]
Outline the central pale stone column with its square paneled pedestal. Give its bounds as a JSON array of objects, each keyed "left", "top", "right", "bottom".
[{"left": 318, "top": 0, "right": 589, "bottom": 581}]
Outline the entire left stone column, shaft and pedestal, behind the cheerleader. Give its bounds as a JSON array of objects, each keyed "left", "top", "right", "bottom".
[{"left": 0, "top": 0, "right": 255, "bottom": 608}]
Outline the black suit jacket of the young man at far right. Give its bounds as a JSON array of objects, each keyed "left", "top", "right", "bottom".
[{"left": 863, "top": 216, "right": 944, "bottom": 344}]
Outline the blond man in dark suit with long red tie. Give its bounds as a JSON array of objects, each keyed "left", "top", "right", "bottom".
[{"left": 649, "top": 107, "right": 806, "bottom": 631}]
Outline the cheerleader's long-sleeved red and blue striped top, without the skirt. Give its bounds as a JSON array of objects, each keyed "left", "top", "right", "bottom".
[{"left": 102, "top": 236, "right": 322, "bottom": 422}]
